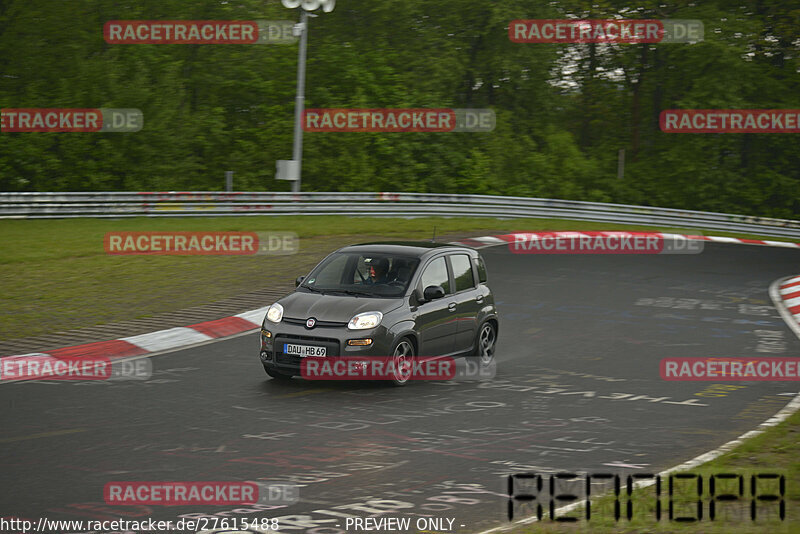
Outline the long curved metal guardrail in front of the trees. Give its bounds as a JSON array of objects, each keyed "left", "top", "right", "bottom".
[{"left": 0, "top": 192, "right": 800, "bottom": 238}]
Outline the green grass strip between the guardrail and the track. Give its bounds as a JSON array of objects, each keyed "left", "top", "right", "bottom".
[{"left": 0, "top": 216, "right": 800, "bottom": 339}]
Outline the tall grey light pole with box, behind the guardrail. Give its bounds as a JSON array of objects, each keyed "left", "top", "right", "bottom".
[{"left": 275, "top": 0, "right": 336, "bottom": 193}]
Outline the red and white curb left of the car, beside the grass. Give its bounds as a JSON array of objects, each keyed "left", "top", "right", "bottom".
[{"left": 0, "top": 306, "right": 269, "bottom": 372}]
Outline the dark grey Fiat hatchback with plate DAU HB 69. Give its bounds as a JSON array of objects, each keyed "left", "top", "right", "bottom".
[{"left": 260, "top": 242, "right": 498, "bottom": 385}]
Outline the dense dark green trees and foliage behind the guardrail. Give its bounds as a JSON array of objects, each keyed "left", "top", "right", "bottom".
[{"left": 0, "top": 0, "right": 800, "bottom": 218}]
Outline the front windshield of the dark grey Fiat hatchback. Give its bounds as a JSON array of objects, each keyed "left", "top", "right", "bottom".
[{"left": 300, "top": 252, "right": 419, "bottom": 298}]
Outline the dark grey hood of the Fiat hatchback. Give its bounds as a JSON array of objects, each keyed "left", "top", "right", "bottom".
[{"left": 279, "top": 291, "right": 404, "bottom": 323}]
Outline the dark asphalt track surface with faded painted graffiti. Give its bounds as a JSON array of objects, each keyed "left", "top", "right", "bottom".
[{"left": 0, "top": 243, "right": 800, "bottom": 534}]
